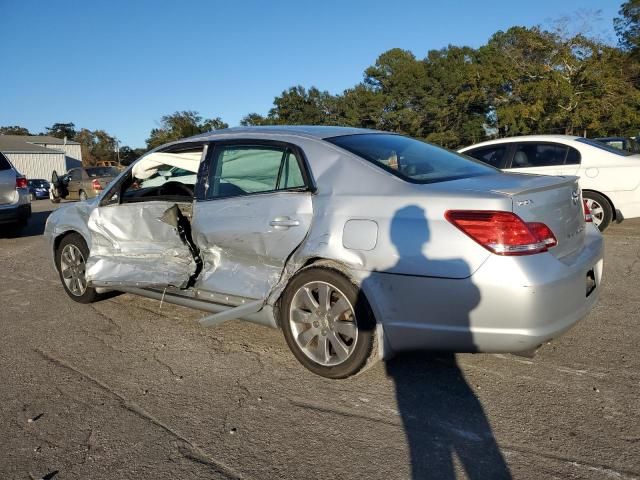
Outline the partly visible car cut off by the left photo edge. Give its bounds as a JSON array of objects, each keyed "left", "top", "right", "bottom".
[{"left": 0, "top": 153, "right": 31, "bottom": 230}]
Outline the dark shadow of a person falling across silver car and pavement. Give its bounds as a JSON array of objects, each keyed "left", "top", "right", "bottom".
[{"left": 365, "top": 205, "right": 511, "bottom": 480}]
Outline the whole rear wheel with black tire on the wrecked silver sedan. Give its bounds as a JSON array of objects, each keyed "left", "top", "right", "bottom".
[{"left": 279, "top": 267, "right": 376, "bottom": 379}]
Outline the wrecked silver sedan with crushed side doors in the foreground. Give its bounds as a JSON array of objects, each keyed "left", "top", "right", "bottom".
[{"left": 45, "top": 127, "right": 603, "bottom": 378}]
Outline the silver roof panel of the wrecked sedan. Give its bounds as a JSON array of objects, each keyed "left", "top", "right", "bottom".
[{"left": 184, "top": 125, "right": 384, "bottom": 140}]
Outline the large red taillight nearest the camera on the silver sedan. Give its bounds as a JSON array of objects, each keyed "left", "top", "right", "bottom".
[{"left": 445, "top": 210, "right": 558, "bottom": 255}]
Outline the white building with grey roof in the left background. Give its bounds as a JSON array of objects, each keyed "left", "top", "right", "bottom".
[{"left": 0, "top": 135, "right": 82, "bottom": 180}]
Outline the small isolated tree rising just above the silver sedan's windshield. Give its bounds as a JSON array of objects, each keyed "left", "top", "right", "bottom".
[{"left": 146, "top": 110, "right": 229, "bottom": 149}]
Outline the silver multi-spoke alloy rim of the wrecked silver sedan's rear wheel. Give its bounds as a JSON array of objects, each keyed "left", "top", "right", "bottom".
[{"left": 289, "top": 282, "right": 358, "bottom": 367}]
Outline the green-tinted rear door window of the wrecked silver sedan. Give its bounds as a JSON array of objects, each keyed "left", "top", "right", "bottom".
[{"left": 207, "top": 145, "right": 305, "bottom": 198}]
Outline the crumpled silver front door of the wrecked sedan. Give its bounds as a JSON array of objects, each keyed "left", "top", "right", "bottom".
[{"left": 86, "top": 202, "right": 195, "bottom": 287}]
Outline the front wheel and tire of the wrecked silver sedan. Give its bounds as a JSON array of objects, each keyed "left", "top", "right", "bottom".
[{"left": 55, "top": 233, "right": 100, "bottom": 303}]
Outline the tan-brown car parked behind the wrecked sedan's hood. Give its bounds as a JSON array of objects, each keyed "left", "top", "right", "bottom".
[{"left": 49, "top": 167, "right": 120, "bottom": 203}]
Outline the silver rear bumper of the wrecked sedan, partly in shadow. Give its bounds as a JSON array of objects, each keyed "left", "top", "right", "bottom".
[{"left": 362, "top": 226, "right": 603, "bottom": 353}]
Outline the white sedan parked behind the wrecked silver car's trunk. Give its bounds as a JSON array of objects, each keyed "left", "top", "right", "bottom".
[{"left": 459, "top": 135, "right": 640, "bottom": 231}]
